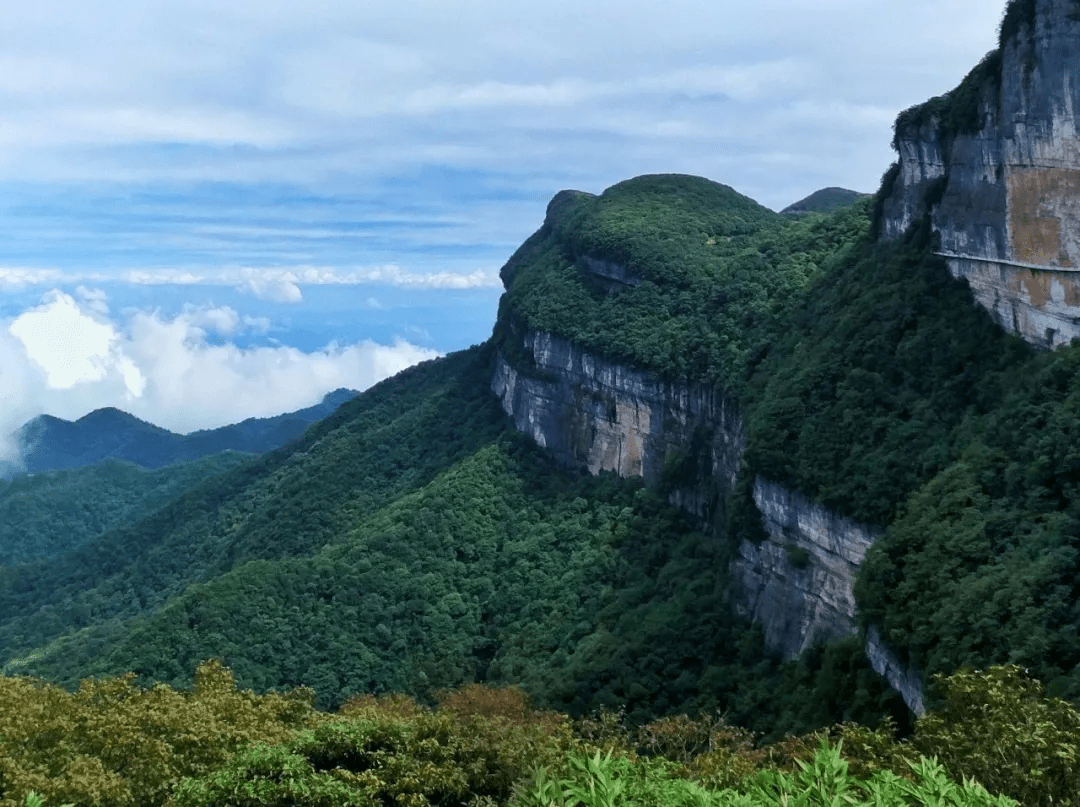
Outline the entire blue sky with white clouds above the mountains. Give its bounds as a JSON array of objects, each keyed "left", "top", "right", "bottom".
[{"left": 0, "top": 0, "right": 1004, "bottom": 454}]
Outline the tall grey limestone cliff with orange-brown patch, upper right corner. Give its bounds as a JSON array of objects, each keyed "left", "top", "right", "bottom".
[{"left": 880, "top": 0, "right": 1080, "bottom": 348}]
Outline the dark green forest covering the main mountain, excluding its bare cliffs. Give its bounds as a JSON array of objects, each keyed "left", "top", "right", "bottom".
[{"left": 8, "top": 164, "right": 1080, "bottom": 732}]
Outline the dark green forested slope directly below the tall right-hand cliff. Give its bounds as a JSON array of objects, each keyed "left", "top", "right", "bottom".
[{"left": 746, "top": 219, "right": 1080, "bottom": 699}]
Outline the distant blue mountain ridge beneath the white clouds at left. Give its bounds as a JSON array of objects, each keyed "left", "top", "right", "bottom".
[{"left": 7, "top": 389, "right": 357, "bottom": 476}]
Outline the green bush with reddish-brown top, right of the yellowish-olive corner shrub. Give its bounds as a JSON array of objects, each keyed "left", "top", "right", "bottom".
[{"left": 174, "top": 701, "right": 570, "bottom": 807}]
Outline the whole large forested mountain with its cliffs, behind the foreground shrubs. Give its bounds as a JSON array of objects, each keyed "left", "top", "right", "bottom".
[{"left": 0, "top": 0, "right": 1080, "bottom": 736}]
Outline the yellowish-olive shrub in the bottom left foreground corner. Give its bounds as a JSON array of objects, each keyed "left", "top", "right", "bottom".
[{"left": 0, "top": 661, "right": 324, "bottom": 807}]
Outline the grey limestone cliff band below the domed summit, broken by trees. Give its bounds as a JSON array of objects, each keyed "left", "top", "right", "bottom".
[{"left": 491, "top": 333, "right": 921, "bottom": 709}]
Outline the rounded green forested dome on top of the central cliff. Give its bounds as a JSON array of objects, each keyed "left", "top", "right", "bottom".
[{"left": 496, "top": 176, "right": 867, "bottom": 387}]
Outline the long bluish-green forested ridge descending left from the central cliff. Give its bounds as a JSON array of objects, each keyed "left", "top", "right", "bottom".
[{"left": 0, "top": 351, "right": 505, "bottom": 674}]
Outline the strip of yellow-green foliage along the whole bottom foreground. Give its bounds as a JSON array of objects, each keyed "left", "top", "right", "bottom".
[{"left": 0, "top": 662, "right": 1080, "bottom": 807}]
